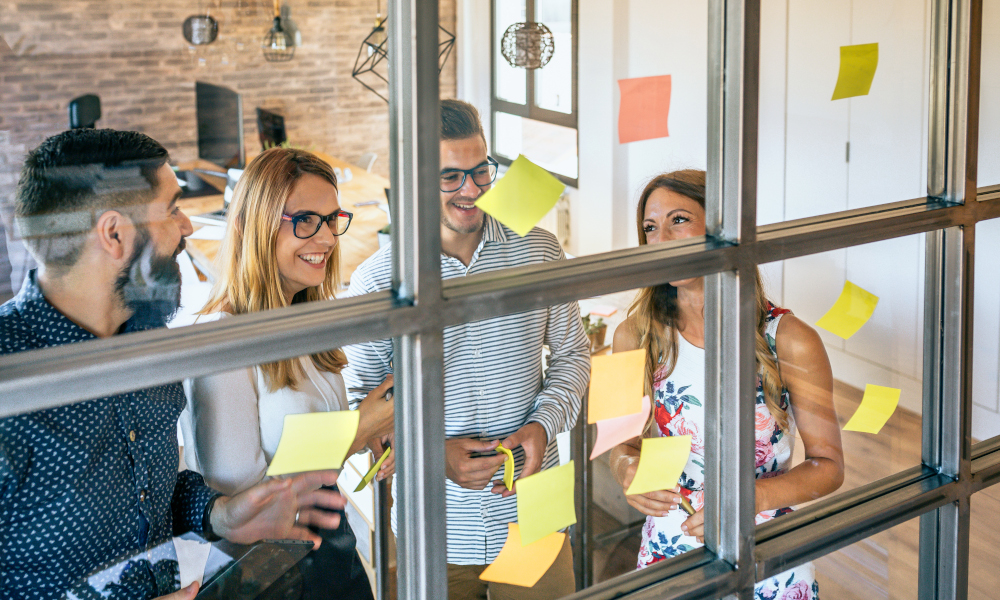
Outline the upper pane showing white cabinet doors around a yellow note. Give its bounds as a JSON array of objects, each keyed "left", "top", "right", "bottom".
[{"left": 757, "top": 0, "right": 928, "bottom": 224}]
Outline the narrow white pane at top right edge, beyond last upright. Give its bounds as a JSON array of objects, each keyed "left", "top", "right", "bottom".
[{"left": 978, "top": 0, "right": 1000, "bottom": 187}]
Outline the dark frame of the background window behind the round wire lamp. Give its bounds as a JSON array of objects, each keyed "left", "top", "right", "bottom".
[{"left": 490, "top": 0, "right": 580, "bottom": 187}]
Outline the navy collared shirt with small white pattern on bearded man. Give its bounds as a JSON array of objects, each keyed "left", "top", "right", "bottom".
[{"left": 0, "top": 271, "right": 216, "bottom": 599}]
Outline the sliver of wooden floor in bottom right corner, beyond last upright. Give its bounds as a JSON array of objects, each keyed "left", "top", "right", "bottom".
[{"left": 969, "top": 485, "right": 1000, "bottom": 600}]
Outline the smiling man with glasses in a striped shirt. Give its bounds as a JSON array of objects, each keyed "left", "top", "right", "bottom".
[{"left": 344, "top": 100, "right": 590, "bottom": 600}]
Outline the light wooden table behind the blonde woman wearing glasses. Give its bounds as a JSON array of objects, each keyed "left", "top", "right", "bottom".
[{"left": 178, "top": 152, "right": 389, "bottom": 285}]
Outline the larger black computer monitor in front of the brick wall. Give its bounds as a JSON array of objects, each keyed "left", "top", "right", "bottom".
[{"left": 194, "top": 81, "right": 245, "bottom": 169}]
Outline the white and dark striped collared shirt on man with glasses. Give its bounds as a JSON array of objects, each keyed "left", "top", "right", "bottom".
[{"left": 344, "top": 215, "right": 590, "bottom": 565}]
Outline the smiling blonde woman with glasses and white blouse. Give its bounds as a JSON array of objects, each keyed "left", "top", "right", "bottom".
[{"left": 182, "top": 148, "right": 394, "bottom": 599}]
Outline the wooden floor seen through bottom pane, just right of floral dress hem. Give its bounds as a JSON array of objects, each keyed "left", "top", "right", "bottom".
[{"left": 812, "top": 518, "right": 920, "bottom": 600}]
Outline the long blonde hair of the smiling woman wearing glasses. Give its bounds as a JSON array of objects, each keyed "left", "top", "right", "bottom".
[{"left": 199, "top": 148, "right": 347, "bottom": 392}]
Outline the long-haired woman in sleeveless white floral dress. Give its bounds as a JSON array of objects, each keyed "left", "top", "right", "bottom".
[{"left": 611, "top": 170, "right": 844, "bottom": 600}]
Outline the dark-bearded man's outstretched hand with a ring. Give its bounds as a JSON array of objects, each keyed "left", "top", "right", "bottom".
[{"left": 211, "top": 471, "right": 346, "bottom": 548}]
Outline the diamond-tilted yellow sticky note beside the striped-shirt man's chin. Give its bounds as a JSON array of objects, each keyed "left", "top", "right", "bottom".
[{"left": 476, "top": 156, "right": 566, "bottom": 237}]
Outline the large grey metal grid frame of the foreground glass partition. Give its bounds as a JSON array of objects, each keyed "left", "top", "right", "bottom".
[{"left": 0, "top": 0, "right": 1000, "bottom": 600}]
